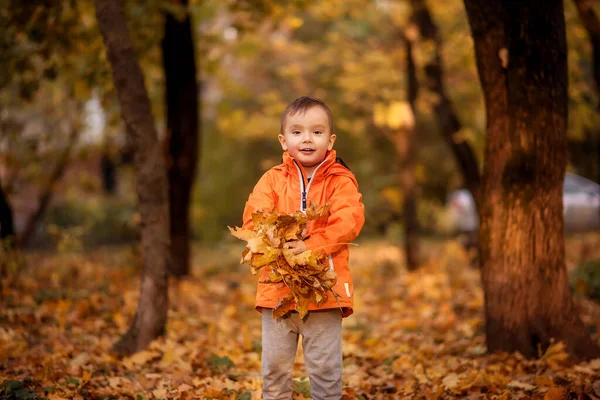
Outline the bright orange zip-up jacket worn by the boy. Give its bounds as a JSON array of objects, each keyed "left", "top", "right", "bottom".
[{"left": 243, "top": 150, "right": 365, "bottom": 317}]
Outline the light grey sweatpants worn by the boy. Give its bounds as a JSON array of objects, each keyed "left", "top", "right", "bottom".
[{"left": 262, "top": 308, "right": 342, "bottom": 400}]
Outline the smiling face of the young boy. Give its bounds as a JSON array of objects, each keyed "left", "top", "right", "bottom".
[{"left": 279, "top": 106, "right": 336, "bottom": 176}]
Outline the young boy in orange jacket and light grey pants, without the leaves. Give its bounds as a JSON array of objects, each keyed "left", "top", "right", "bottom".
[{"left": 243, "top": 96, "right": 365, "bottom": 399}]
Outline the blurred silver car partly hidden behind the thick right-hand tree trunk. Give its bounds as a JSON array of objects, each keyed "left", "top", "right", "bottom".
[{"left": 448, "top": 172, "right": 600, "bottom": 234}]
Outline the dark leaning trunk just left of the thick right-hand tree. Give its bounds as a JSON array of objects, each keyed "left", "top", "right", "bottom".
[{"left": 411, "top": 0, "right": 480, "bottom": 202}]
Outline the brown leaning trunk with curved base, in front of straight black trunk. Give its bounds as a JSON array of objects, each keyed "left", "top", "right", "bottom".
[{"left": 95, "top": 0, "right": 169, "bottom": 354}]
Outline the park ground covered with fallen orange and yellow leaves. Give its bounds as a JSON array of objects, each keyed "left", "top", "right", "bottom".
[{"left": 0, "top": 234, "right": 600, "bottom": 400}]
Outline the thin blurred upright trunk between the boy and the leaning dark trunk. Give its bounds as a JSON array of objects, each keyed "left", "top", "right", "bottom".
[{"left": 395, "top": 39, "right": 420, "bottom": 271}]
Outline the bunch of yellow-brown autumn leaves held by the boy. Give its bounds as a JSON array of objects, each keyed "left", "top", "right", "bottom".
[{"left": 229, "top": 204, "right": 337, "bottom": 318}]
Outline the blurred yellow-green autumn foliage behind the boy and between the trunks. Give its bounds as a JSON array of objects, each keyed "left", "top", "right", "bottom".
[{"left": 0, "top": 0, "right": 600, "bottom": 253}]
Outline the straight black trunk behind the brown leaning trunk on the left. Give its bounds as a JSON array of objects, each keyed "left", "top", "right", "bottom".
[{"left": 162, "top": 0, "right": 199, "bottom": 277}]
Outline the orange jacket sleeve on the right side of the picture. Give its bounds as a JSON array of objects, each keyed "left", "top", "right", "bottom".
[{"left": 304, "top": 177, "right": 365, "bottom": 254}]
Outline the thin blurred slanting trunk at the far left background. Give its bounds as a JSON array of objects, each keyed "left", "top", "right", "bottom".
[{"left": 18, "top": 123, "right": 80, "bottom": 247}]
